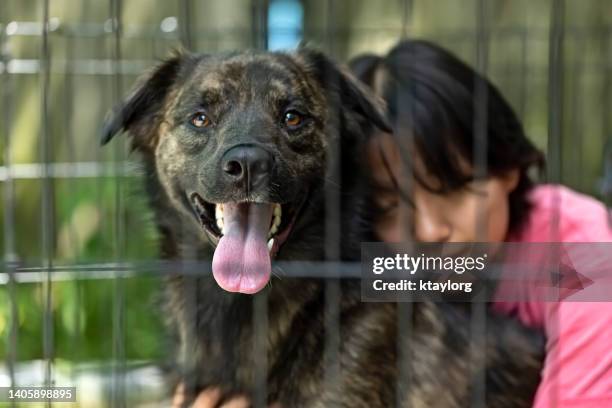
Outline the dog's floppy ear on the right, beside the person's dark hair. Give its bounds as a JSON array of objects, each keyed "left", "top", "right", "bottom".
[{"left": 298, "top": 45, "right": 391, "bottom": 132}]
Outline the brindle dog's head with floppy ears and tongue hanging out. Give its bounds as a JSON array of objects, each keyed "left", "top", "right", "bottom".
[{"left": 102, "top": 48, "right": 389, "bottom": 293}]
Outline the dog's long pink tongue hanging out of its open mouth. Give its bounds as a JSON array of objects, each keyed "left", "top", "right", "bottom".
[{"left": 213, "top": 203, "right": 273, "bottom": 293}]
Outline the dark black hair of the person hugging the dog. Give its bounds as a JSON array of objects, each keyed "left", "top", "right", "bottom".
[{"left": 349, "top": 40, "right": 544, "bottom": 236}]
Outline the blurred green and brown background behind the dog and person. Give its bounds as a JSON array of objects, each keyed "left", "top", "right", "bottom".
[{"left": 0, "top": 0, "right": 612, "bottom": 407}]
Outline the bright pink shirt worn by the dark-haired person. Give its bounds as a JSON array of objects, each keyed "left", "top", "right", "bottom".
[{"left": 493, "top": 185, "right": 612, "bottom": 408}]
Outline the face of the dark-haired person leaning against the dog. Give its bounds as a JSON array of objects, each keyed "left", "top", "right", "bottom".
[{"left": 368, "top": 134, "right": 519, "bottom": 242}]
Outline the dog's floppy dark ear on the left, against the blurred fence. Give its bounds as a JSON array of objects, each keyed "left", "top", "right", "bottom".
[{"left": 100, "top": 51, "right": 187, "bottom": 146}]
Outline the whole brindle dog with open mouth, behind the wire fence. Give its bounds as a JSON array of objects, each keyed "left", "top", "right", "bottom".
[{"left": 102, "top": 47, "right": 542, "bottom": 408}]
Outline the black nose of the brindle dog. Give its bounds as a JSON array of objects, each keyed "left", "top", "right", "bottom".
[{"left": 222, "top": 146, "right": 272, "bottom": 189}]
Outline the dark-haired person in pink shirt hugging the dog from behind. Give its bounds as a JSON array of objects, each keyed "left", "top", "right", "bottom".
[{"left": 351, "top": 41, "right": 612, "bottom": 407}]
